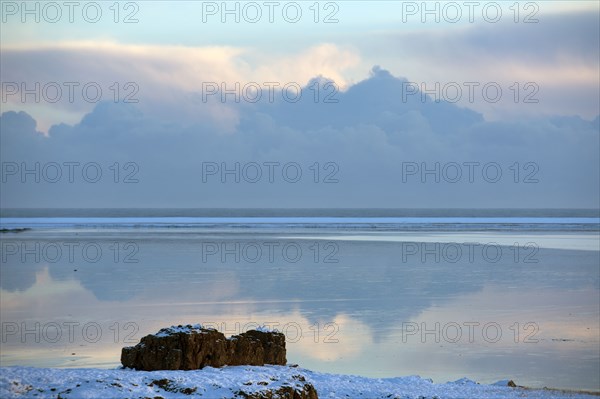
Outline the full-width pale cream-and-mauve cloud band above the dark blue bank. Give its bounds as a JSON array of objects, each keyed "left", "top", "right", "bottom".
[{"left": 0, "top": 10, "right": 600, "bottom": 128}]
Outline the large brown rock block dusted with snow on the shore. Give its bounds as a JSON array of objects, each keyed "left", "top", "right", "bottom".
[{"left": 121, "top": 325, "right": 287, "bottom": 371}]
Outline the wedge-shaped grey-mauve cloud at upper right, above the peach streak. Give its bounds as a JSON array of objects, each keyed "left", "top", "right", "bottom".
[{"left": 360, "top": 13, "right": 600, "bottom": 66}]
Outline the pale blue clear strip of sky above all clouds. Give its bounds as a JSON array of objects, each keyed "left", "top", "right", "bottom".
[{"left": 1, "top": 0, "right": 598, "bottom": 46}]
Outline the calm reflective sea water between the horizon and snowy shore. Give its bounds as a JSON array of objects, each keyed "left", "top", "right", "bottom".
[{"left": 0, "top": 209, "right": 600, "bottom": 391}]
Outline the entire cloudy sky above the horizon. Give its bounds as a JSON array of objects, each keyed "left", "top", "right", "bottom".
[{"left": 0, "top": 1, "right": 600, "bottom": 208}]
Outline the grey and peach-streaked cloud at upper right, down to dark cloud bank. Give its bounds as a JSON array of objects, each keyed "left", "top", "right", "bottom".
[{"left": 355, "top": 11, "right": 600, "bottom": 120}]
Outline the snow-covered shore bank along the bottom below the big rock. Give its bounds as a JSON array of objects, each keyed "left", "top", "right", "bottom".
[{"left": 0, "top": 366, "right": 598, "bottom": 399}]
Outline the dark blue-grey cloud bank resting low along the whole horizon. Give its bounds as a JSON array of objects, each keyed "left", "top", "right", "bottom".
[{"left": 0, "top": 67, "right": 599, "bottom": 208}]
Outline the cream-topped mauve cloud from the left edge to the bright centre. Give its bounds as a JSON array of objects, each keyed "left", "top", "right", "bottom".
[{"left": 0, "top": 41, "right": 358, "bottom": 131}]
